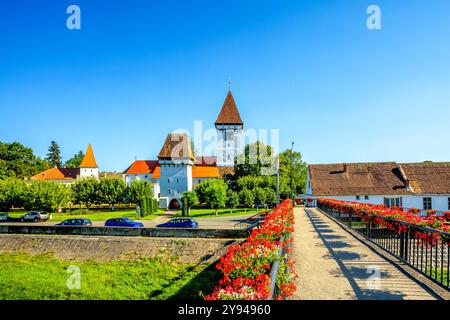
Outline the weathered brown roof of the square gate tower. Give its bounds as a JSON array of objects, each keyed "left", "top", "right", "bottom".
[{"left": 158, "top": 133, "right": 194, "bottom": 160}]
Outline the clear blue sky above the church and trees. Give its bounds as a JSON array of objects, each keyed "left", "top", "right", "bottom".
[{"left": 0, "top": 0, "right": 450, "bottom": 171}]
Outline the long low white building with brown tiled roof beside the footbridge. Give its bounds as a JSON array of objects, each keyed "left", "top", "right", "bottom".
[{"left": 306, "top": 162, "right": 450, "bottom": 211}]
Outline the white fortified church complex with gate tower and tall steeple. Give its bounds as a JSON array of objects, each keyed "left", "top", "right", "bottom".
[{"left": 122, "top": 91, "right": 244, "bottom": 209}]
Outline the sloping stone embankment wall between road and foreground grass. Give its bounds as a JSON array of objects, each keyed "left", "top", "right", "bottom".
[{"left": 0, "top": 234, "right": 240, "bottom": 263}]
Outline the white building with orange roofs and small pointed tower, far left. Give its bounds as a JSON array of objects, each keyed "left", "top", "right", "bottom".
[{"left": 31, "top": 144, "right": 99, "bottom": 184}]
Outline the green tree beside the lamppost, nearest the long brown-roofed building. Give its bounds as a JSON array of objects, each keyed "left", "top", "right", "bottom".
[{"left": 280, "top": 149, "right": 308, "bottom": 197}]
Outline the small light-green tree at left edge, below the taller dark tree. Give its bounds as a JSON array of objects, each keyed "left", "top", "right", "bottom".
[{"left": 0, "top": 178, "right": 27, "bottom": 211}]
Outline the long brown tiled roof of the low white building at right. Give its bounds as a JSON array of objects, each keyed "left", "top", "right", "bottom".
[{"left": 309, "top": 162, "right": 450, "bottom": 196}]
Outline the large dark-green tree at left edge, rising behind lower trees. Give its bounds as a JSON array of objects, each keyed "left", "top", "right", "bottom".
[{"left": 0, "top": 142, "right": 49, "bottom": 179}]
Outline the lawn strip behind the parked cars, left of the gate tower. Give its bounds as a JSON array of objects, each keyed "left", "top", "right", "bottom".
[{"left": 5, "top": 210, "right": 164, "bottom": 222}]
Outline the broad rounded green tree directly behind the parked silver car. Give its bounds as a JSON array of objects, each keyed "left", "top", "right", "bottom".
[{"left": 24, "top": 181, "right": 71, "bottom": 212}]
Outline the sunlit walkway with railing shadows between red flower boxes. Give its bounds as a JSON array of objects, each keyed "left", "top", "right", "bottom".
[{"left": 292, "top": 208, "right": 434, "bottom": 300}]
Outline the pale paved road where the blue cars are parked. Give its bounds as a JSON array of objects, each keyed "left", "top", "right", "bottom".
[{"left": 0, "top": 211, "right": 254, "bottom": 229}]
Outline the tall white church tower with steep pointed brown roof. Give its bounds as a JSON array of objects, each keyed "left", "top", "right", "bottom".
[{"left": 215, "top": 90, "right": 244, "bottom": 166}]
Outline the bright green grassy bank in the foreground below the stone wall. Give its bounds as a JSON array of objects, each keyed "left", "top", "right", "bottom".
[{"left": 0, "top": 253, "right": 220, "bottom": 300}]
